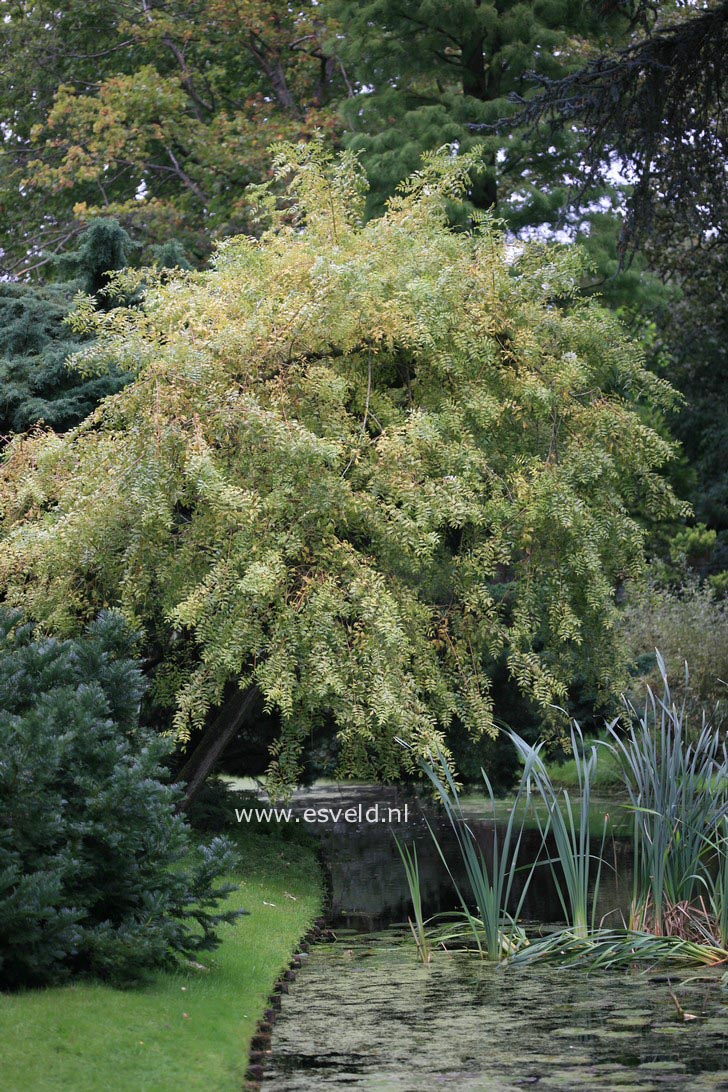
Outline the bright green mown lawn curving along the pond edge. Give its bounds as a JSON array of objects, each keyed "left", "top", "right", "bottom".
[{"left": 0, "top": 830, "right": 322, "bottom": 1092}]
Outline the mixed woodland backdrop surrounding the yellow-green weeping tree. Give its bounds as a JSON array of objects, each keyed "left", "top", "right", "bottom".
[{"left": 0, "top": 0, "right": 728, "bottom": 786}]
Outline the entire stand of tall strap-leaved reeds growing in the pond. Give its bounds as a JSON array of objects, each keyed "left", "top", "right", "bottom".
[{"left": 399, "top": 653, "right": 728, "bottom": 969}]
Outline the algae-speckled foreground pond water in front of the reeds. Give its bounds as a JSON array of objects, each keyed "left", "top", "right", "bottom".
[{"left": 263, "top": 930, "right": 728, "bottom": 1092}]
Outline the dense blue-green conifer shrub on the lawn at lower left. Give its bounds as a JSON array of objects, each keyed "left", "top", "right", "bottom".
[{"left": 0, "top": 610, "right": 243, "bottom": 989}]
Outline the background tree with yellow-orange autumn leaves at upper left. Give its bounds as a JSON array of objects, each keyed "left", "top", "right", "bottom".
[{"left": 0, "top": 0, "right": 346, "bottom": 274}]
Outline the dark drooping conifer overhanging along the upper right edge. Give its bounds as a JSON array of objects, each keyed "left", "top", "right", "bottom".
[{"left": 502, "top": 0, "right": 728, "bottom": 571}]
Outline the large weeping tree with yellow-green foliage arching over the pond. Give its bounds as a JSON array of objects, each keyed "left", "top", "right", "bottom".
[{"left": 0, "top": 143, "right": 676, "bottom": 796}]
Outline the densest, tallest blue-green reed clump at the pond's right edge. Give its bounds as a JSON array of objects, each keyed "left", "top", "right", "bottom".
[{"left": 512, "top": 653, "right": 728, "bottom": 968}]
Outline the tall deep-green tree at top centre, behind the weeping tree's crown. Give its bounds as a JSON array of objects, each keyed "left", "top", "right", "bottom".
[{"left": 326, "top": 0, "right": 626, "bottom": 221}]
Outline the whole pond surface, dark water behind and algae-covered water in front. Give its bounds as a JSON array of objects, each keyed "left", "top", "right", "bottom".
[{"left": 258, "top": 786, "right": 728, "bottom": 1092}]
